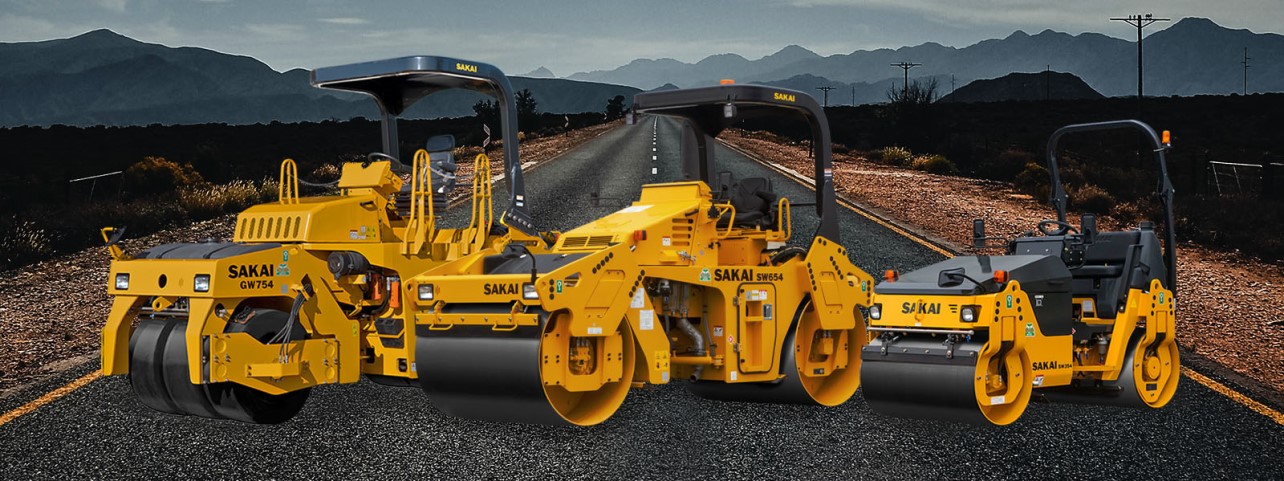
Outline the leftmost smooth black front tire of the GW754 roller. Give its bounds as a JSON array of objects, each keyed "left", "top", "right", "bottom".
[{"left": 130, "top": 319, "right": 182, "bottom": 414}]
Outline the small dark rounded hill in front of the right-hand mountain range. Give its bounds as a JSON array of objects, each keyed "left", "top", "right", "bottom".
[{"left": 939, "top": 72, "right": 1104, "bottom": 103}]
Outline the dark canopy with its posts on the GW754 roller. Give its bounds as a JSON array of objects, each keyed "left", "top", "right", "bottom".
[{"left": 312, "top": 55, "right": 538, "bottom": 235}]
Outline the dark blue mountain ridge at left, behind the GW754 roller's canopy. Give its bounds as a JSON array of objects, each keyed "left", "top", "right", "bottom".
[{"left": 0, "top": 30, "right": 639, "bottom": 127}]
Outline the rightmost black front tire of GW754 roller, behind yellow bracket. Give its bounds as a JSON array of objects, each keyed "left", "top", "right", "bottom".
[{"left": 205, "top": 309, "right": 312, "bottom": 425}]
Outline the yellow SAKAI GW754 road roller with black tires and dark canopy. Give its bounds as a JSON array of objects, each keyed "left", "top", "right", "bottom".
[{"left": 101, "top": 56, "right": 538, "bottom": 423}]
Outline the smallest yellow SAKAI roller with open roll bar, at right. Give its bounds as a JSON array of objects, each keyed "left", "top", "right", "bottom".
[{"left": 862, "top": 121, "right": 1180, "bottom": 425}]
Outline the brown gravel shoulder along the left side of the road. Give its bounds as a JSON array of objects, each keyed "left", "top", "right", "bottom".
[{"left": 0, "top": 122, "right": 620, "bottom": 398}]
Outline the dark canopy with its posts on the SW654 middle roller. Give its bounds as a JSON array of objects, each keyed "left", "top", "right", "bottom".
[{"left": 633, "top": 85, "right": 840, "bottom": 241}]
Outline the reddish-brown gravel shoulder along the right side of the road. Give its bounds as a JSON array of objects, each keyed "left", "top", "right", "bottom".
[{"left": 720, "top": 131, "right": 1284, "bottom": 391}]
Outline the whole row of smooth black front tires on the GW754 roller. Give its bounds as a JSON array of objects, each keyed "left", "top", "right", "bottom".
[{"left": 130, "top": 309, "right": 311, "bottom": 425}]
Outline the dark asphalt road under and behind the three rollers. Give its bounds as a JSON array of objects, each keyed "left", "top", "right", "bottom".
[{"left": 0, "top": 118, "right": 1284, "bottom": 480}]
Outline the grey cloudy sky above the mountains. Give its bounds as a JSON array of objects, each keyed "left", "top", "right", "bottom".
[{"left": 0, "top": 0, "right": 1284, "bottom": 77}]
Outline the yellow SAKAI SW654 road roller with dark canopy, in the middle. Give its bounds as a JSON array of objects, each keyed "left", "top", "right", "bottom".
[{"left": 406, "top": 85, "right": 873, "bottom": 425}]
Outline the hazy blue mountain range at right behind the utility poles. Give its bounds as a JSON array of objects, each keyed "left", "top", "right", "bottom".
[{"left": 568, "top": 18, "right": 1284, "bottom": 98}]
